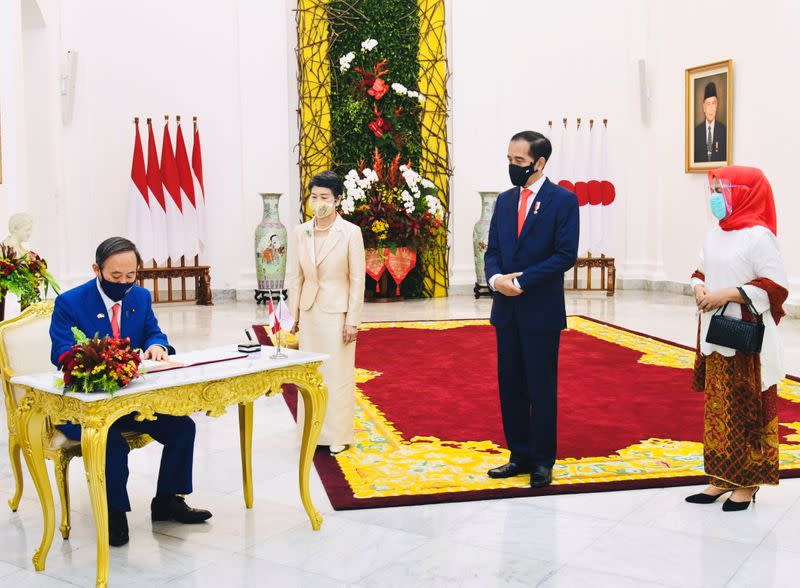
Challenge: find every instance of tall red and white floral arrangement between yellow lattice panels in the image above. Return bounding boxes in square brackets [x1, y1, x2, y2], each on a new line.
[334, 38, 446, 289]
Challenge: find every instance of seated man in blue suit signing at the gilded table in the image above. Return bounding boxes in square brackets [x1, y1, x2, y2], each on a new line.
[50, 237, 211, 546]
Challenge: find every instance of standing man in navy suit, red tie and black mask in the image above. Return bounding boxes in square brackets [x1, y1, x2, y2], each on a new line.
[484, 131, 579, 488]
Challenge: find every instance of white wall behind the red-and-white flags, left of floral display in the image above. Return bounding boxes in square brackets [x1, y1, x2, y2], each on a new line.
[0, 0, 298, 289]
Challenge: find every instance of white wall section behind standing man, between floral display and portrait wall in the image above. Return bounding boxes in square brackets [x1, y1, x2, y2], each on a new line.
[450, 0, 656, 284]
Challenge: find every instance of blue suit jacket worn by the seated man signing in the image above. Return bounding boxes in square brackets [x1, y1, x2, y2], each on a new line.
[50, 278, 174, 367]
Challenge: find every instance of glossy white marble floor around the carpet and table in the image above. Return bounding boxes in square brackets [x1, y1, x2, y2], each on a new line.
[0, 292, 800, 588]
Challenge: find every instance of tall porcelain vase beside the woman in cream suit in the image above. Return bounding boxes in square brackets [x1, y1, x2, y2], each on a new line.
[255, 192, 287, 300]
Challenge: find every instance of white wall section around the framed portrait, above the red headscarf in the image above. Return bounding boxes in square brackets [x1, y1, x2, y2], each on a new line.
[648, 0, 800, 304]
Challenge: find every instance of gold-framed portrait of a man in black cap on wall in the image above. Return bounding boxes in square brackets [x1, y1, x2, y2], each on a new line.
[686, 59, 733, 172]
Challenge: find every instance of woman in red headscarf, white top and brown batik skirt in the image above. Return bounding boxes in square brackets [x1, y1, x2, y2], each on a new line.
[686, 166, 789, 511]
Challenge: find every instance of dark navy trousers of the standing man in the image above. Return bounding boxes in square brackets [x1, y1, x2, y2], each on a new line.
[496, 321, 561, 467]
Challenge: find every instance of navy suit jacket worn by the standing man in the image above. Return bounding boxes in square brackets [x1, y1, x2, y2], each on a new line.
[484, 179, 580, 334]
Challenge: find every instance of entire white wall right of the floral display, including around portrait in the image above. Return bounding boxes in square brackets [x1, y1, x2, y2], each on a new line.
[450, 0, 800, 304]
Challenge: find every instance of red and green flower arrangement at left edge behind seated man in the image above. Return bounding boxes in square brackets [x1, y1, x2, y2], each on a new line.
[0, 244, 60, 308]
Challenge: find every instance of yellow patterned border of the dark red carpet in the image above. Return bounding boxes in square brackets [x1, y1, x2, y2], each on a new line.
[336, 317, 800, 498]
